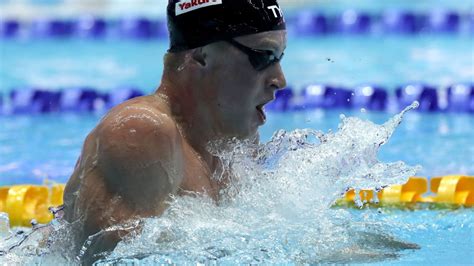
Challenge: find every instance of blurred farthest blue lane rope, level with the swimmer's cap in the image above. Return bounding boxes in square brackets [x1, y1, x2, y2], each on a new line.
[0, 10, 474, 40]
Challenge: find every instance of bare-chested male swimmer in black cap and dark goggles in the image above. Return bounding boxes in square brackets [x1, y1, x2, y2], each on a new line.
[64, 0, 286, 261]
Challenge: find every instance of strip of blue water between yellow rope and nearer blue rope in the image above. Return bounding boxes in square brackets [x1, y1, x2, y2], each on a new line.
[0, 110, 474, 185]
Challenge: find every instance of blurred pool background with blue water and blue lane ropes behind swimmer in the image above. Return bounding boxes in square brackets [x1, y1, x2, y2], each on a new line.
[0, 0, 474, 185]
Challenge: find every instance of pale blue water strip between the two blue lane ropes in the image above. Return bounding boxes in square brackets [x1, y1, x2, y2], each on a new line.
[0, 34, 474, 93]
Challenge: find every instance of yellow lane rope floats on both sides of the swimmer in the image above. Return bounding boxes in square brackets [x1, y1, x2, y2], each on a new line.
[0, 175, 474, 229]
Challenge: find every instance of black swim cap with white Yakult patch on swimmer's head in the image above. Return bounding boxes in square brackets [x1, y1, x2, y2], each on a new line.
[167, 0, 286, 52]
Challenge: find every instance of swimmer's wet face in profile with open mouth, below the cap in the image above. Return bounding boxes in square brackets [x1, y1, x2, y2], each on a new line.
[204, 30, 286, 138]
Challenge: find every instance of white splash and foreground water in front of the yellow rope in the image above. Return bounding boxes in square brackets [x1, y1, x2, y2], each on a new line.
[0, 103, 474, 264]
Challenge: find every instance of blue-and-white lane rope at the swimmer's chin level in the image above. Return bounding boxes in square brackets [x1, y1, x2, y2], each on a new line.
[0, 83, 474, 115]
